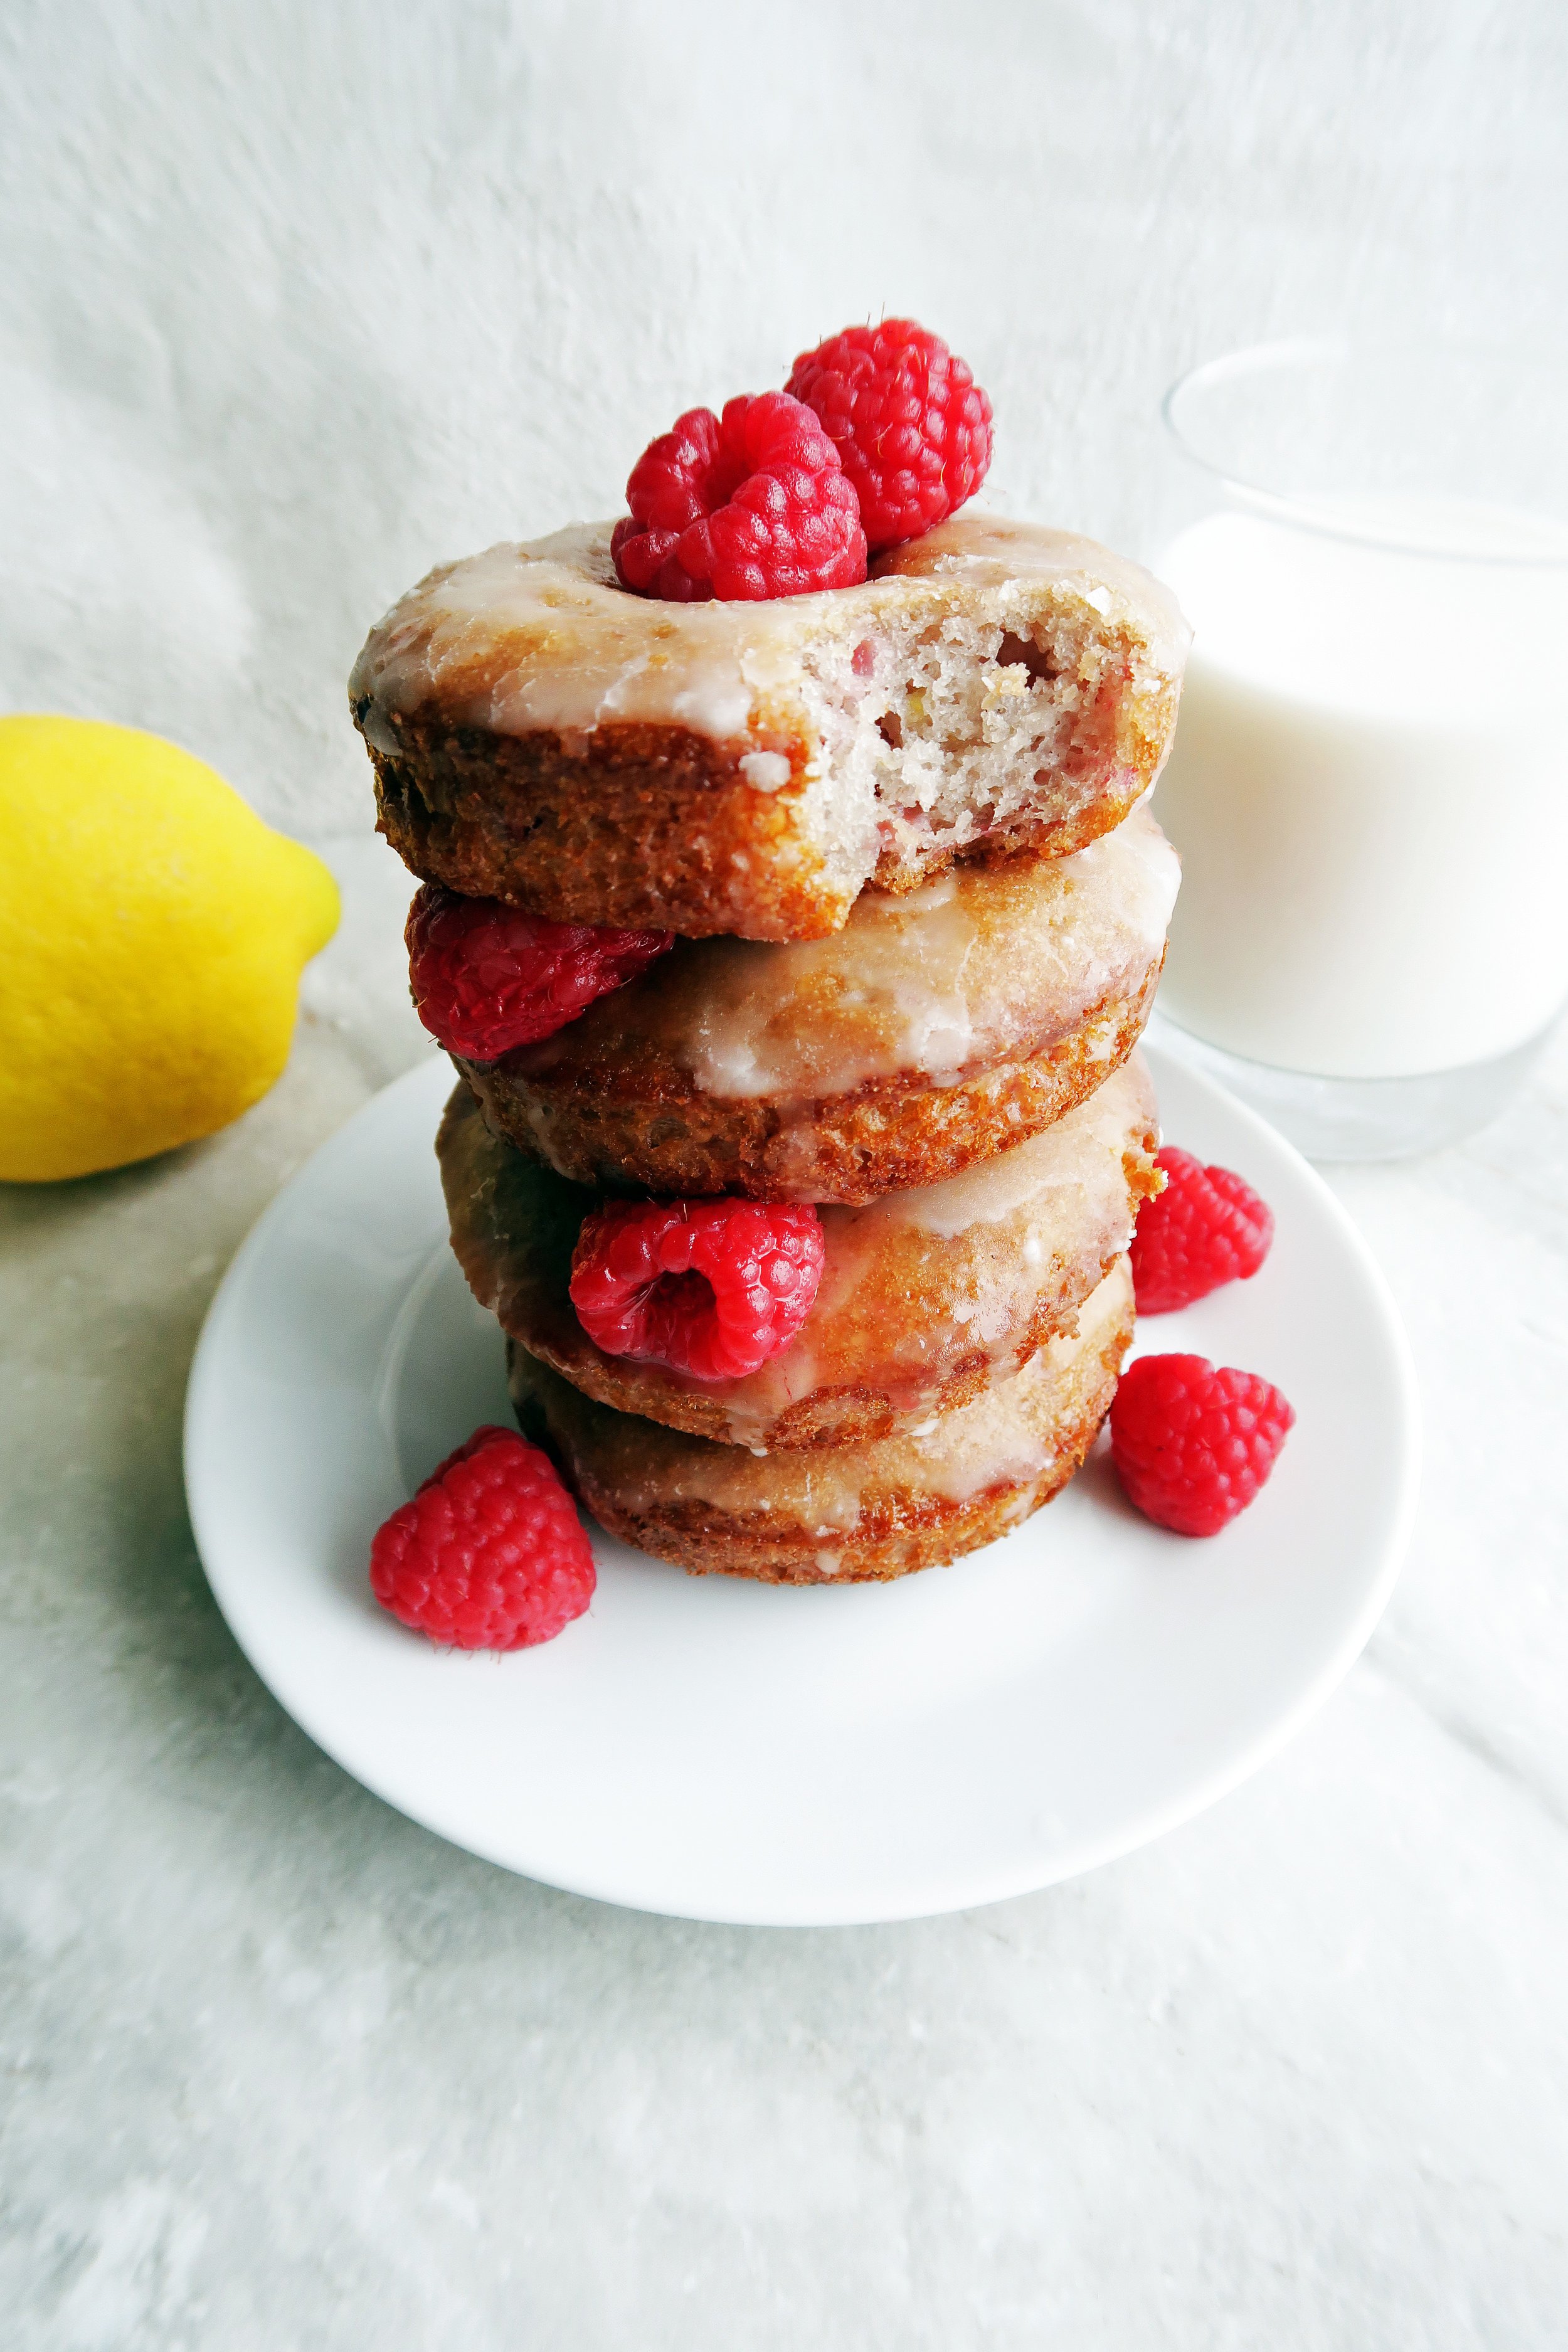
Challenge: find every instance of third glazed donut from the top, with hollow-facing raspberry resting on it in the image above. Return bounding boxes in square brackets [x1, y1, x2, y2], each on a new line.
[435, 1061, 1159, 1454]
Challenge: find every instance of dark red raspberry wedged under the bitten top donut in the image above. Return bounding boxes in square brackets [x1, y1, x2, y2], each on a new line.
[405, 882, 675, 1061]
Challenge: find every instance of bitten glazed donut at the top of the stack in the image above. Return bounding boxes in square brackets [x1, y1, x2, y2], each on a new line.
[348, 513, 1187, 938]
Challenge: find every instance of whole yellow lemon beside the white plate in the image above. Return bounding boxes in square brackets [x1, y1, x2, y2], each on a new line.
[0, 718, 339, 1181]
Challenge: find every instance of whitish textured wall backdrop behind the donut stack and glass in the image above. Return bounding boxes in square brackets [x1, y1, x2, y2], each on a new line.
[0, 0, 1568, 835]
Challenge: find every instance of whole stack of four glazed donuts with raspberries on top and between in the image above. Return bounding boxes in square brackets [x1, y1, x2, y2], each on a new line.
[350, 322, 1185, 1583]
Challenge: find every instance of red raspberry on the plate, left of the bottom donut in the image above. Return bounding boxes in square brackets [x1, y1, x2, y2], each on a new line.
[369, 1426, 595, 1649]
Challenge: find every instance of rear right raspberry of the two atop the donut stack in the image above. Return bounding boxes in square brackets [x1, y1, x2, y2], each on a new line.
[788, 317, 992, 555]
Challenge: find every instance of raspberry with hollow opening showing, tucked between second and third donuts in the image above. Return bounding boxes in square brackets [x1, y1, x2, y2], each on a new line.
[571, 1200, 823, 1380]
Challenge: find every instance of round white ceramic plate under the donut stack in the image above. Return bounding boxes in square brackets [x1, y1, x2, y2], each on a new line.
[186, 1051, 1417, 1926]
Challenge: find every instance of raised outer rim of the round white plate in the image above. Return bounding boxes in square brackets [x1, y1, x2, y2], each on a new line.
[181, 1037, 1422, 1929]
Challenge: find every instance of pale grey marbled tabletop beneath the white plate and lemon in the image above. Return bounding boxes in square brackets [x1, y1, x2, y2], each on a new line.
[0, 840, 1568, 2352]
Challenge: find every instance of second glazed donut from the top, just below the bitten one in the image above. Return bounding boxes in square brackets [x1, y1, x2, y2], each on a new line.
[458, 809, 1180, 1204]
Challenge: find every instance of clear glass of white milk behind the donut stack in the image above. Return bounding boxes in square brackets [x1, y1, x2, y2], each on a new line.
[1150, 341, 1568, 1160]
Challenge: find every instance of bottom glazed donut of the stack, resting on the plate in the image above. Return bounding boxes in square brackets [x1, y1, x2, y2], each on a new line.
[508, 1258, 1133, 1586]
